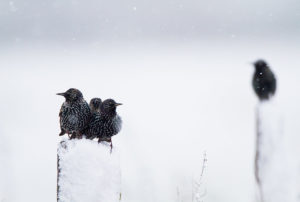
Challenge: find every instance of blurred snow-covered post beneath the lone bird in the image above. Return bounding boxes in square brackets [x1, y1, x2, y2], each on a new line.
[255, 101, 295, 202]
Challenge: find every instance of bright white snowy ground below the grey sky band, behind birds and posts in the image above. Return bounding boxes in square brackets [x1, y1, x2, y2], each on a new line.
[0, 40, 300, 202]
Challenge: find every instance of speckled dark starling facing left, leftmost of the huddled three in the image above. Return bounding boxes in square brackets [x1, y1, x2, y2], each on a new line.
[57, 88, 91, 139]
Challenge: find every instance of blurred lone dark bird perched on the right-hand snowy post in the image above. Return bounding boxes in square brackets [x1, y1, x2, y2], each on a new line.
[252, 60, 276, 101]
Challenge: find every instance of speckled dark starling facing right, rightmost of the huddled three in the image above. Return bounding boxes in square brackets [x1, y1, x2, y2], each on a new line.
[86, 99, 122, 147]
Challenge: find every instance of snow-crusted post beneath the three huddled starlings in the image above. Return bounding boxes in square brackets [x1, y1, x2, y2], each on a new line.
[57, 139, 121, 202]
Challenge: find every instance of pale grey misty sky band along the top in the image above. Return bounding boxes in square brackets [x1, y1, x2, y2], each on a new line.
[0, 0, 300, 43]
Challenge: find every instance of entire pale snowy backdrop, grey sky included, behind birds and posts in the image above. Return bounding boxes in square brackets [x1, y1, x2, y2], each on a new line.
[0, 0, 300, 202]
